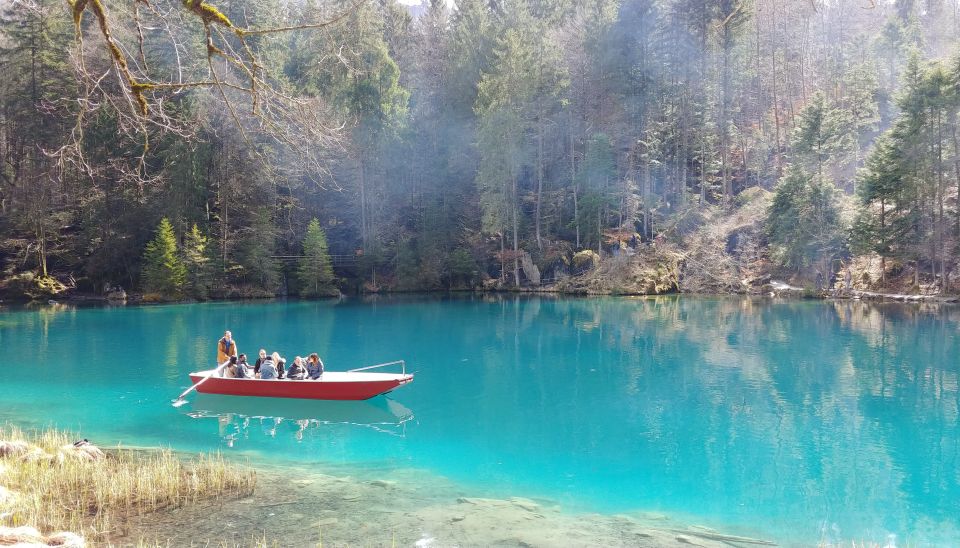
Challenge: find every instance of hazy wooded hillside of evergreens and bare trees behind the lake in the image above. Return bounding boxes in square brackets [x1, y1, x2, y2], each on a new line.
[0, 0, 960, 300]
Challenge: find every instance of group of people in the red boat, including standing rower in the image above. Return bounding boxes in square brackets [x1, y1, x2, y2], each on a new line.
[217, 331, 323, 381]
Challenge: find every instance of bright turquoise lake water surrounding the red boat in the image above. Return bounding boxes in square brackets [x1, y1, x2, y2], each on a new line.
[0, 296, 960, 544]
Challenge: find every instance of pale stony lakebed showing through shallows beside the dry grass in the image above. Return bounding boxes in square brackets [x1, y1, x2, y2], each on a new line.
[120, 470, 760, 548]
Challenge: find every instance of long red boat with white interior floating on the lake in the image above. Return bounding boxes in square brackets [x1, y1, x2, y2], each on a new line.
[187, 360, 413, 400]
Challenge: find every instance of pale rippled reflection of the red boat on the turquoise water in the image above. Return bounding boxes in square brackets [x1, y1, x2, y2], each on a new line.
[187, 394, 413, 447]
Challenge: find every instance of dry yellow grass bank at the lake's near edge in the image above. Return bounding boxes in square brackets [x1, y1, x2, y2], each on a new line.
[0, 426, 256, 542]
